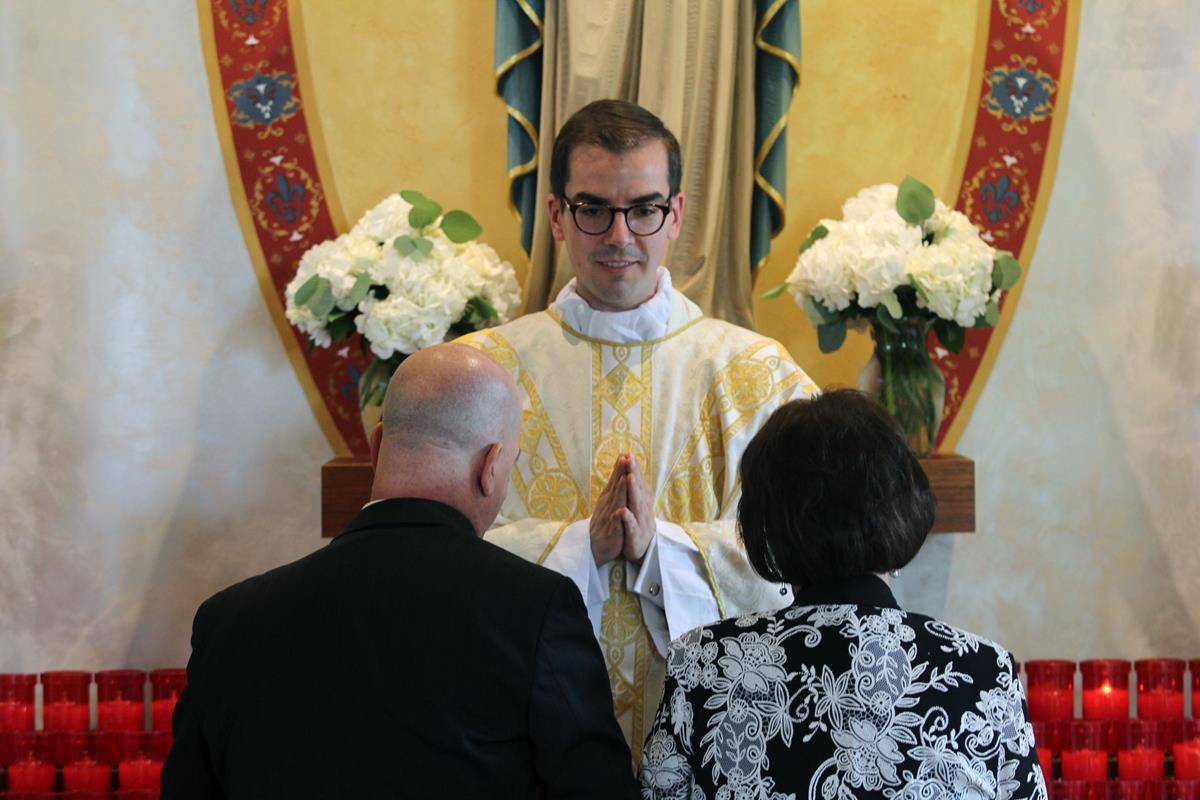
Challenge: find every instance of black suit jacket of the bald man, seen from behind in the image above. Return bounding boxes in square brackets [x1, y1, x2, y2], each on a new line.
[162, 498, 637, 800]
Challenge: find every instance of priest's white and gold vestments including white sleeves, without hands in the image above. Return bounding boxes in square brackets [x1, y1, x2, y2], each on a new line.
[458, 287, 817, 759]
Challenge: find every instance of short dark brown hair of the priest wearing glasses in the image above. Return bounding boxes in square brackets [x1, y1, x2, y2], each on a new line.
[550, 100, 683, 199]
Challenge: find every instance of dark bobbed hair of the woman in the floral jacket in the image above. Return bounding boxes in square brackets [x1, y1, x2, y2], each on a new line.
[738, 389, 937, 587]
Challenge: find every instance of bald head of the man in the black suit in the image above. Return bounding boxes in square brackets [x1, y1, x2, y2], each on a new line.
[371, 344, 521, 534]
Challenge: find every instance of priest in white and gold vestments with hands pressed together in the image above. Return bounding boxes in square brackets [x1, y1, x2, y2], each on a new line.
[461, 101, 816, 753]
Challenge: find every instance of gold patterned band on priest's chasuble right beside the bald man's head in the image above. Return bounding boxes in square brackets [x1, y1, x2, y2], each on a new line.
[456, 331, 589, 556]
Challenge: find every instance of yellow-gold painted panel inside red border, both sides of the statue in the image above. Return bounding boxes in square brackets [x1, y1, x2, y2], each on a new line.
[292, 0, 986, 386]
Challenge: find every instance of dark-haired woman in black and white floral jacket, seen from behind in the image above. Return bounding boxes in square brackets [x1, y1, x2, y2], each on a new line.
[641, 390, 1045, 800]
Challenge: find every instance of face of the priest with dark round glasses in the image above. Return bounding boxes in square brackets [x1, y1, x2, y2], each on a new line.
[548, 140, 683, 311]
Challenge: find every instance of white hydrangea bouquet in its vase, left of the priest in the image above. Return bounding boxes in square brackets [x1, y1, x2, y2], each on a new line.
[286, 191, 521, 408]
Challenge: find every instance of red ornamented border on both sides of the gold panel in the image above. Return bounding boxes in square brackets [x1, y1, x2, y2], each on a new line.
[199, 0, 1070, 453]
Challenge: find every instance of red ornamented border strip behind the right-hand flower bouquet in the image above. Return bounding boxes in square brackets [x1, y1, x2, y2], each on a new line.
[929, 0, 1070, 449]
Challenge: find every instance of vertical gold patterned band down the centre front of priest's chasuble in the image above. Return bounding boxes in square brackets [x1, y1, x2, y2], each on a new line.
[584, 339, 658, 763]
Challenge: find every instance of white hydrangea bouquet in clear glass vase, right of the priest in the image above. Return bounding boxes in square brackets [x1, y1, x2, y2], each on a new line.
[764, 176, 1021, 455]
